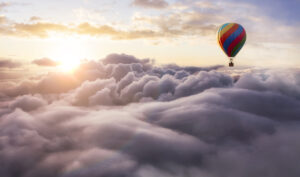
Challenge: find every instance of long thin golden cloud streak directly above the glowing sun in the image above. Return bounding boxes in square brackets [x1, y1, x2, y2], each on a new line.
[0, 22, 165, 40]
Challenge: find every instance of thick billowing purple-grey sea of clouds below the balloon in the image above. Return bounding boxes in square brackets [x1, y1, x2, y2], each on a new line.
[0, 54, 300, 177]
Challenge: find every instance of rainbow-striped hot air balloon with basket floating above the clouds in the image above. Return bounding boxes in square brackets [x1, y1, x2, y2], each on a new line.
[218, 23, 246, 67]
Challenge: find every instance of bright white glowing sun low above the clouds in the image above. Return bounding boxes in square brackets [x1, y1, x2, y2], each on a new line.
[50, 38, 86, 72]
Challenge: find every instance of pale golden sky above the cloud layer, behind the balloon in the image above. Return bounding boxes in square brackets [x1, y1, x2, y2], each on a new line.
[0, 0, 300, 67]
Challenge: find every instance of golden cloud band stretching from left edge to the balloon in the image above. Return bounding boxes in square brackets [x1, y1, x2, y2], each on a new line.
[0, 5, 220, 40]
